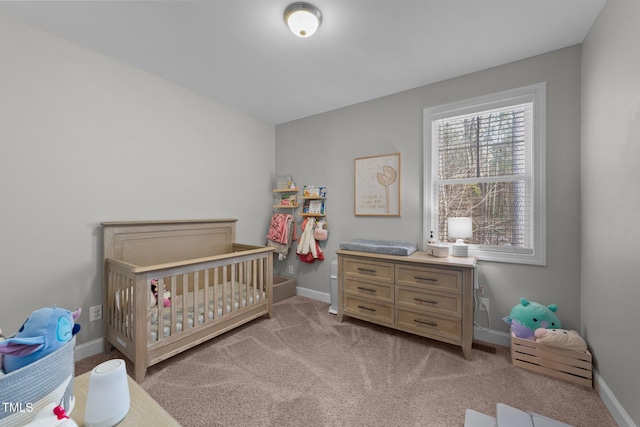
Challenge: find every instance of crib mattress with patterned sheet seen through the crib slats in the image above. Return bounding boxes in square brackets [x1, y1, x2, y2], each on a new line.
[151, 284, 267, 342]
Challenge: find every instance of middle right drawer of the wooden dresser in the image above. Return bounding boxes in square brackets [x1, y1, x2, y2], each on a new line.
[395, 286, 462, 317]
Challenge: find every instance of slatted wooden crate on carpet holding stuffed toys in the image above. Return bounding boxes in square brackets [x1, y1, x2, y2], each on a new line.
[511, 333, 593, 387]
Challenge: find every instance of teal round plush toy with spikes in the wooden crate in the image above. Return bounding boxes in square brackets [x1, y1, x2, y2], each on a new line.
[502, 298, 562, 341]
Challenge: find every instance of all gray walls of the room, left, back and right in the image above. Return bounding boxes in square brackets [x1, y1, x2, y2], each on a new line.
[0, 0, 640, 425]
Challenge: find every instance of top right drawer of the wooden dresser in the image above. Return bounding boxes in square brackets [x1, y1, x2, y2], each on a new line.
[396, 265, 462, 293]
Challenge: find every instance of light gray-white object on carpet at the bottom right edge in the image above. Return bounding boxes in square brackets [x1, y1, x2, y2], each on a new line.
[464, 403, 573, 427]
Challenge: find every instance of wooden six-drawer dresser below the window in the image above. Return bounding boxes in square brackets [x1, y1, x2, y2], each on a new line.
[336, 250, 476, 360]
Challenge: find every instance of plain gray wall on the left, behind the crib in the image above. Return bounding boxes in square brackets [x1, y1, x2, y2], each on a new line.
[0, 13, 275, 344]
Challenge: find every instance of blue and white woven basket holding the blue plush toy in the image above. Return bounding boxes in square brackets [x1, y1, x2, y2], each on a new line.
[0, 337, 76, 427]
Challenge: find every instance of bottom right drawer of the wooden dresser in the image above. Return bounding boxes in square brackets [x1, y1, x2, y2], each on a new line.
[396, 308, 462, 342]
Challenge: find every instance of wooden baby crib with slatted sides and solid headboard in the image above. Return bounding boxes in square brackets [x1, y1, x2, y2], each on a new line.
[101, 219, 274, 383]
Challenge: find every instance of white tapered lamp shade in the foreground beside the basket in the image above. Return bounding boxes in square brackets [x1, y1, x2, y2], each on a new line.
[84, 359, 131, 427]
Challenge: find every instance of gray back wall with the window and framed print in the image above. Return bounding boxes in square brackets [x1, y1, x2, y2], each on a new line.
[276, 46, 581, 333]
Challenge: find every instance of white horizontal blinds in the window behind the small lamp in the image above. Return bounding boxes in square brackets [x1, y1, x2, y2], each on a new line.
[431, 102, 533, 253]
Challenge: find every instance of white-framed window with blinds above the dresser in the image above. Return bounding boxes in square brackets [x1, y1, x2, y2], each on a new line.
[423, 83, 546, 265]
